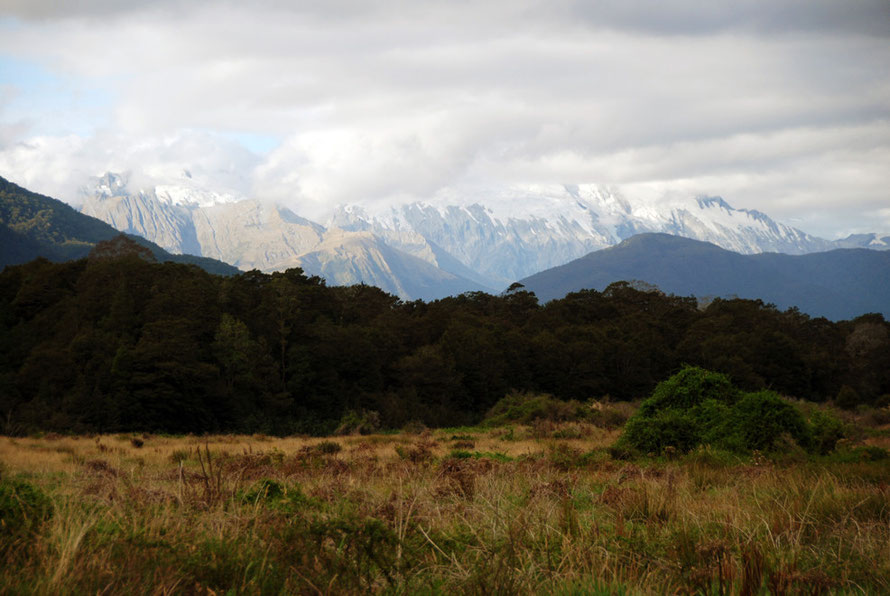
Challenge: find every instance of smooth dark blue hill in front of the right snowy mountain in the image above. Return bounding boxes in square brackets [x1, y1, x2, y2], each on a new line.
[520, 234, 890, 320]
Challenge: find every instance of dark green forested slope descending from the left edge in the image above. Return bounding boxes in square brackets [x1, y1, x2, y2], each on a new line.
[0, 173, 238, 275]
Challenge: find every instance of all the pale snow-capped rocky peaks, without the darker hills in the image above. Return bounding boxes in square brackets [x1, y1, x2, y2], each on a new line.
[83, 174, 835, 298]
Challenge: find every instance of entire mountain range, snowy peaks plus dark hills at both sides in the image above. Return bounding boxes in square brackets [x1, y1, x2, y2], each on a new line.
[0, 174, 890, 319]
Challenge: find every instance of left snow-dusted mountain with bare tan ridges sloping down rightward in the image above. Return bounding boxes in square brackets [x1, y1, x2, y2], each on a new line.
[81, 174, 491, 299]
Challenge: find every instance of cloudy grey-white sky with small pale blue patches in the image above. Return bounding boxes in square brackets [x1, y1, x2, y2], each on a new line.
[0, 0, 890, 239]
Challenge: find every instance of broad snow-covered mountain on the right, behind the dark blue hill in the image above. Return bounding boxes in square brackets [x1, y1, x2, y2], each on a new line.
[327, 185, 833, 287]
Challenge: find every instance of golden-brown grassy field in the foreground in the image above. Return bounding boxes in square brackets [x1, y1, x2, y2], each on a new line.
[0, 423, 890, 594]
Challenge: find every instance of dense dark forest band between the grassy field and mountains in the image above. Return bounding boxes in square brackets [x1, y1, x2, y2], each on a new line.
[0, 249, 890, 433]
